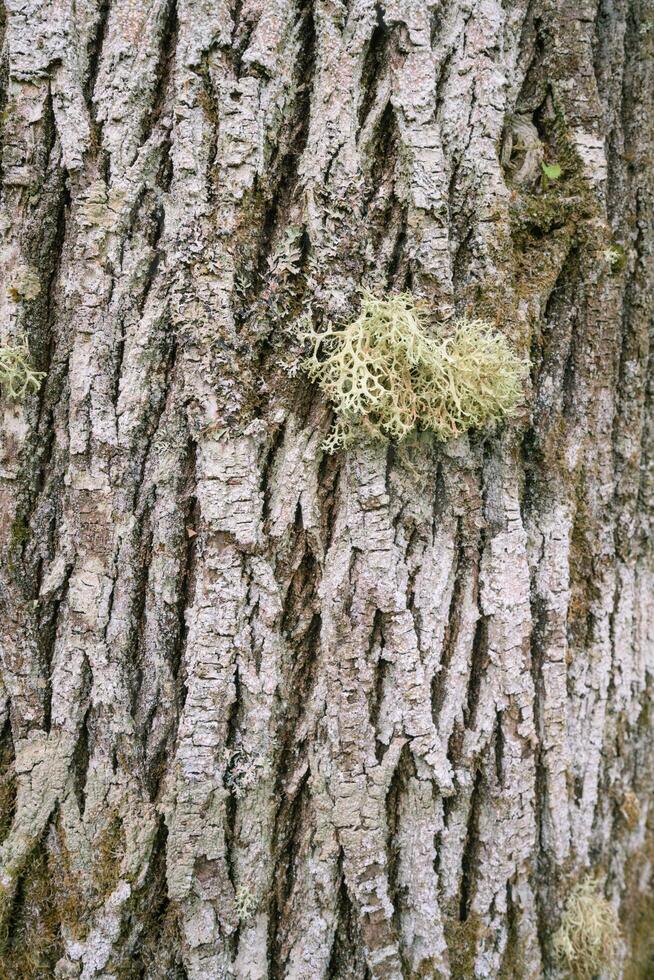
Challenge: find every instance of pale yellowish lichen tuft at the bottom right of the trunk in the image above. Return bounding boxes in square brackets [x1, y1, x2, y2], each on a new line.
[553, 878, 620, 980]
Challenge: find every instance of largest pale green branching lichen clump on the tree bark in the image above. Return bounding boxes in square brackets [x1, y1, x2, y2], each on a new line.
[301, 293, 528, 452]
